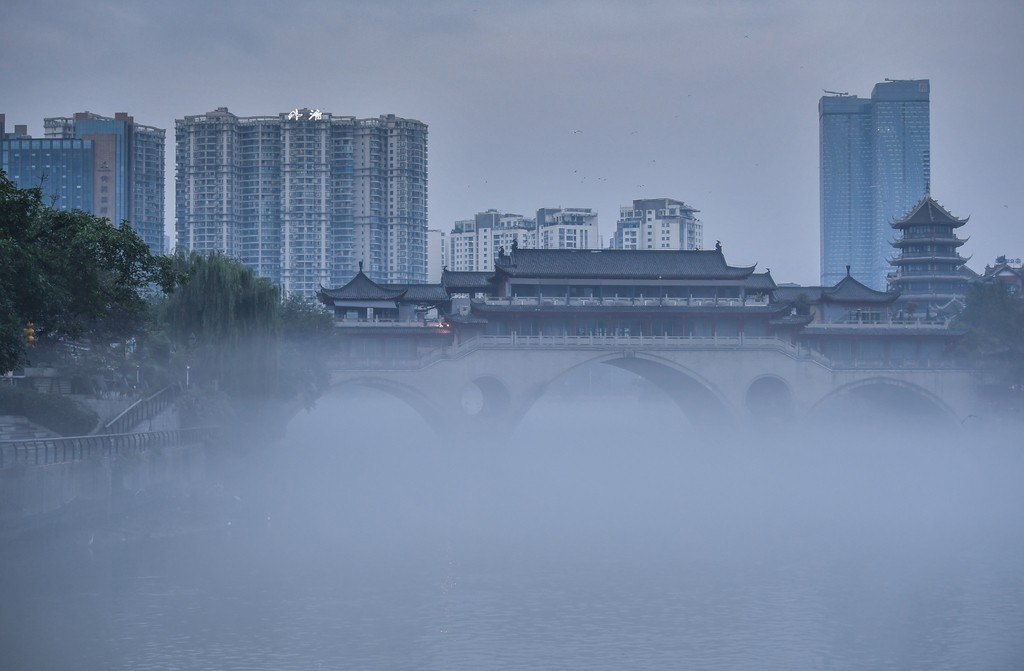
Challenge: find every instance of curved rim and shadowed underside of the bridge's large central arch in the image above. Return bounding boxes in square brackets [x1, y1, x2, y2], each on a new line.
[512, 351, 735, 425]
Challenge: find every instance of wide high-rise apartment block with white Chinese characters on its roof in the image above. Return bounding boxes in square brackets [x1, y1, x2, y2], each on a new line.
[175, 108, 428, 296]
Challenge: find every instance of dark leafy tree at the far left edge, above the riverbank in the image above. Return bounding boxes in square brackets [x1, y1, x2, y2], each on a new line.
[0, 171, 180, 371]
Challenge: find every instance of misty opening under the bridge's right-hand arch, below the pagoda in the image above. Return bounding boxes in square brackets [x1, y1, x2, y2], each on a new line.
[810, 377, 956, 426]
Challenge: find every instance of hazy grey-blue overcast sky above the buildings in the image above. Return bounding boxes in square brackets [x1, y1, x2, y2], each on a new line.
[0, 0, 1024, 285]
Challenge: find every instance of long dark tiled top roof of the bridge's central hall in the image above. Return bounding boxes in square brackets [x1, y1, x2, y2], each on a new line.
[495, 249, 755, 280]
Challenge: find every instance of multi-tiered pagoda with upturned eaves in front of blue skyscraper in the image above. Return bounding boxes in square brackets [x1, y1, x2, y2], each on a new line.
[889, 193, 974, 314]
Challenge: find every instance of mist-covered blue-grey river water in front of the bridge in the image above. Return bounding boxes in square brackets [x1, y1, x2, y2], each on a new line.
[0, 395, 1024, 671]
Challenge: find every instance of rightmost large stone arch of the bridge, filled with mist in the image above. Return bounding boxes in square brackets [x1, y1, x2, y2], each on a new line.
[810, 375, 956, 421]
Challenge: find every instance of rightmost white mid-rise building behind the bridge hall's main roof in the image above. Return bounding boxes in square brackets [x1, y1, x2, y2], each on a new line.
[611, 198, 703, 249]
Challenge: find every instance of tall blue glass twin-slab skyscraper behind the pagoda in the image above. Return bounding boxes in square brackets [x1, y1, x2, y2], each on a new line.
[818, 79, 931, 291]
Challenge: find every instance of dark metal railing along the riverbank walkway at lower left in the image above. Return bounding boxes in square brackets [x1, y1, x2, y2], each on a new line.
[0, 427, 218, 469]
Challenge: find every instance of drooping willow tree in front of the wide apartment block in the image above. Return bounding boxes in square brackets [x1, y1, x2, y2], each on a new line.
[157, 252, 281, 396]
